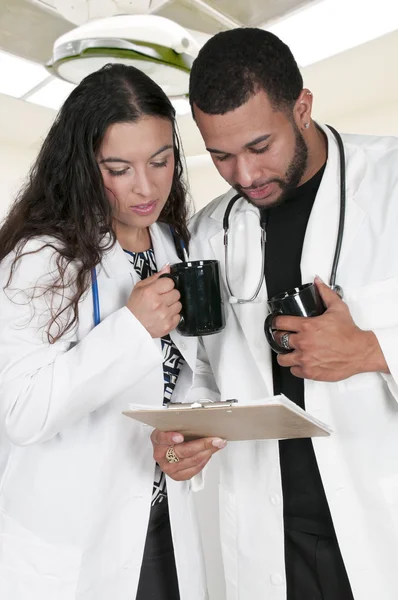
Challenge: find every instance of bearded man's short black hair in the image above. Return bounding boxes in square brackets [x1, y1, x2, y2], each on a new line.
[189, 27, 303, 115]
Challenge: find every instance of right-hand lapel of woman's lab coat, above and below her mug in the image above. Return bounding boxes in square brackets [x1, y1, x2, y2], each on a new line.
[150, 223, 197, 372]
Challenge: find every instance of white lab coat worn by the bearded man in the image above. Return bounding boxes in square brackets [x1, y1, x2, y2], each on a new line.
[188, 125, 398, 600]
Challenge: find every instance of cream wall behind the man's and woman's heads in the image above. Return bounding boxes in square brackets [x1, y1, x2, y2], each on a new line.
[0, 26, 398, 156]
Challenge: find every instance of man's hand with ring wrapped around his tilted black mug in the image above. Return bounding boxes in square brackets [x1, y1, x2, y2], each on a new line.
[274, 277, 389, 381]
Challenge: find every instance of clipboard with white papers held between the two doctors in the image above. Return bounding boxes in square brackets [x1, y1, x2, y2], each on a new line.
[123, 394, 331, 441]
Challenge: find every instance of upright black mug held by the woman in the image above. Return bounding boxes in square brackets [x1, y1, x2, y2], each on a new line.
[160, 260, 225, 336]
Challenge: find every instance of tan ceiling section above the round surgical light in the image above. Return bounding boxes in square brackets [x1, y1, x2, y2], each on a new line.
[0, 0, 316, 64]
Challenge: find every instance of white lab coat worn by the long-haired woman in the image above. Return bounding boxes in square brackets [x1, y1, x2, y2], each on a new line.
[0, 224, 211, 600]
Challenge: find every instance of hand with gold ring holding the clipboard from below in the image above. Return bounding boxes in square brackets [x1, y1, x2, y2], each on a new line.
[151, 429, 227, 481]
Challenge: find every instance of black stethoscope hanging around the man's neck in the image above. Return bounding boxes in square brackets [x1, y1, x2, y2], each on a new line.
[223, 125, 346, 304]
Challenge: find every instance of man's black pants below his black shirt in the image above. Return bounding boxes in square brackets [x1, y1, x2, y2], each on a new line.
[285, 528, 354, 600]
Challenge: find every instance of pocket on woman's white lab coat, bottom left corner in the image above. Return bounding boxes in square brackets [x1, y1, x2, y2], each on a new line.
[0, 511, 81, 600]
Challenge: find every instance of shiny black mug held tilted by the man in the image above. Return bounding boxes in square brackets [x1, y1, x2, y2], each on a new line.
[264, 283, 326, 354]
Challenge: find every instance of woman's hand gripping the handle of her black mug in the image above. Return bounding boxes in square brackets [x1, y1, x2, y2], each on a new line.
[127, 265, 182, 338]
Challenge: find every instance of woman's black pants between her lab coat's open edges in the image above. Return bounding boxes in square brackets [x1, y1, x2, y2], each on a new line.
[136, 499, 180, 600]
